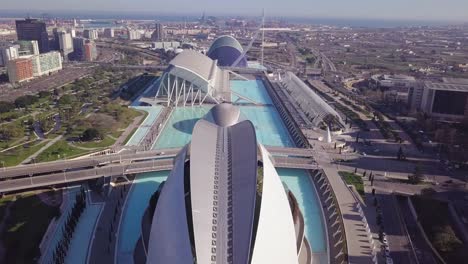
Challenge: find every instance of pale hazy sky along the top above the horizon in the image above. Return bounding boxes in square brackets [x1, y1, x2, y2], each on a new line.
[0, 0, 468, 21]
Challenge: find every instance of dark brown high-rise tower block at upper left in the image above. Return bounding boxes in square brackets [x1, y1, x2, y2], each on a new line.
[16, 18, 50, 53]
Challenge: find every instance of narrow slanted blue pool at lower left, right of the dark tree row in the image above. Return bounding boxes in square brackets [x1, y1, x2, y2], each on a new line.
[65, 204, 102, 264]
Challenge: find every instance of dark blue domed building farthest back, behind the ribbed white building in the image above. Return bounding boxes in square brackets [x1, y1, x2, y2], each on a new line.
[206, 36, 247, 67]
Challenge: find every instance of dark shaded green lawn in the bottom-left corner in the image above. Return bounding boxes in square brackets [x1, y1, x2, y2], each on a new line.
[2, 193, 60, 263]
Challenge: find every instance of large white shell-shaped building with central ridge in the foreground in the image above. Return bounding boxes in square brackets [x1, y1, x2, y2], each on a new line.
[134, 104, 312, 264]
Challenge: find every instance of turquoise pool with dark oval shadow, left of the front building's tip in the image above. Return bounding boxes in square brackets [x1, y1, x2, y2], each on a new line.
[153, 106, 213, 149]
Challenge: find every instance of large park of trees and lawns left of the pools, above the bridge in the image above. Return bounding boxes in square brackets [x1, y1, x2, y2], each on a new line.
[0, 68, 155, 166]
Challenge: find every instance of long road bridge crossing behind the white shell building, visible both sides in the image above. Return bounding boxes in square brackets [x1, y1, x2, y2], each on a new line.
[0, 147, 318, 192]
